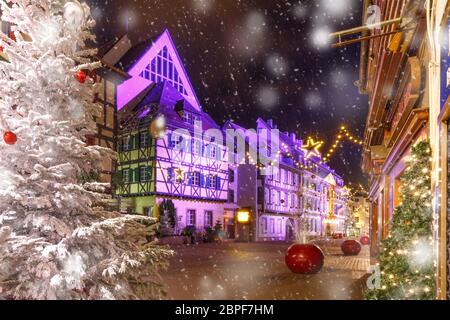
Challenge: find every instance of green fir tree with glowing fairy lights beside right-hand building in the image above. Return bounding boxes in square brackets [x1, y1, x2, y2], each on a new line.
[366, 141, 436, 300]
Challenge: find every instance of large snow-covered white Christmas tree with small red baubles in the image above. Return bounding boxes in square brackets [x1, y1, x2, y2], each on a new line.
[0, 0, 171, 299]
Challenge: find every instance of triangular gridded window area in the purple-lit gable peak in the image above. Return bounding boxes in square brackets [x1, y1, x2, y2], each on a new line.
[139, 47, 187, 95]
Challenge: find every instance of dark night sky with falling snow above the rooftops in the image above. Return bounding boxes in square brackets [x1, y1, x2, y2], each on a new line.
[87, 0, 368, 188]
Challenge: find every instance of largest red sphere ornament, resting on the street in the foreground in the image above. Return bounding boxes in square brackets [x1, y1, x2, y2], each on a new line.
[284, 244, 325, 274]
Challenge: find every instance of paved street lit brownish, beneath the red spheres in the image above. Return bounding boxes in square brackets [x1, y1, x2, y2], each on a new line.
[162, 241, 369, 300]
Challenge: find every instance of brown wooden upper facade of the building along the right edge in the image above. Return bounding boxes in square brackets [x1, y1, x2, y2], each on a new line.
[359, 0, 430, 257]
